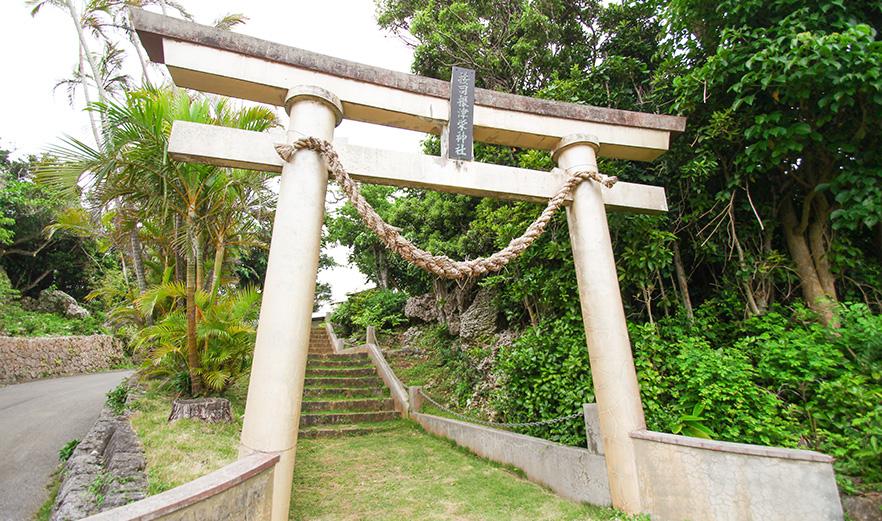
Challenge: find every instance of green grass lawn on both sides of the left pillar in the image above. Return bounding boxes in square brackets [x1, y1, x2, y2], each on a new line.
[132, 391, 627, 520]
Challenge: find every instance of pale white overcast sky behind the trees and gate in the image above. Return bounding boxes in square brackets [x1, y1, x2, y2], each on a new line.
[0, 0, 424, 308]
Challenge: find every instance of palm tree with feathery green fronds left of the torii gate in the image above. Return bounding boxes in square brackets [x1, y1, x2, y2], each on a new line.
[38, 88, 276, 394]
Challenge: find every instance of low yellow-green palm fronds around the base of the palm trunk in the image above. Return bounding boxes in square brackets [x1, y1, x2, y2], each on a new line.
[134, 283, 260, 394]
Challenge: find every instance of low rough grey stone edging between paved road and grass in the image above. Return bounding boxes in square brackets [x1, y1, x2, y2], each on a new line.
[51, 407, 147, 521]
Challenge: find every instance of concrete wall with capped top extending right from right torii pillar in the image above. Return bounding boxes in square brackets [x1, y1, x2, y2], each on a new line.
[631, 431, 843, 521]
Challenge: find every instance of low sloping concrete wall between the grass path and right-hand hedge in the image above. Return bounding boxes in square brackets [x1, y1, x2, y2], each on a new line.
[411, 412, 604, 504]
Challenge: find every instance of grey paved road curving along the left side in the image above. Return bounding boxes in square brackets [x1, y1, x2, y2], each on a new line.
[0, 371, 131, 521]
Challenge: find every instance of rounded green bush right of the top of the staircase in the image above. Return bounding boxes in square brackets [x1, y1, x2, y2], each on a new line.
[329, 289, 407, 335]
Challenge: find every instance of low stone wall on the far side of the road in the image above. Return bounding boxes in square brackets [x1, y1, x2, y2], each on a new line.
[0, 335, 123, 384]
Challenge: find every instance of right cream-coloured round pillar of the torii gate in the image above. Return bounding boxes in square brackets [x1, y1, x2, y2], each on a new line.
[552, 134, 646, 514]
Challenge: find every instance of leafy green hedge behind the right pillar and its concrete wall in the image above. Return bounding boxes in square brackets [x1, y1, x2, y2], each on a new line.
[496, 301, 882, 492]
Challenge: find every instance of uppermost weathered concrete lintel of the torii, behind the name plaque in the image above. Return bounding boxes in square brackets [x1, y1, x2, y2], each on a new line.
[131, 9, 686, 161]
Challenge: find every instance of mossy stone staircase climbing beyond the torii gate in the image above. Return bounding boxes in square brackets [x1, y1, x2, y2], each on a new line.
[300, 328, 399, 438]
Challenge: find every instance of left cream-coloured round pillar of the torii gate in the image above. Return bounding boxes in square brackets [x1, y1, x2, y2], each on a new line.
[239, 86, 343, 521]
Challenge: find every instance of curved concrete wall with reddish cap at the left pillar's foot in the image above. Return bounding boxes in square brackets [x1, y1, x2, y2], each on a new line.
[86, 454, 279, 521]
